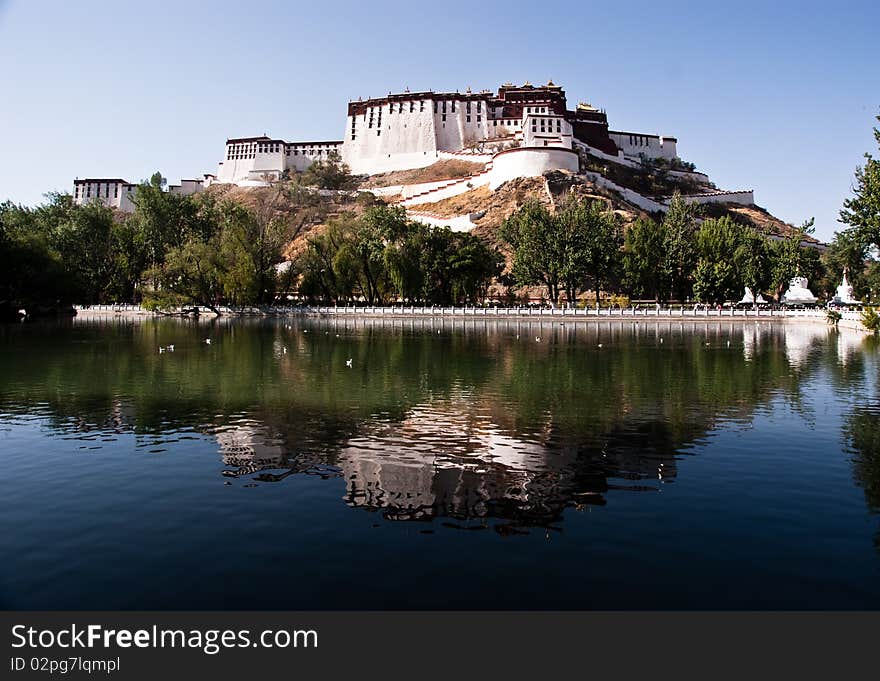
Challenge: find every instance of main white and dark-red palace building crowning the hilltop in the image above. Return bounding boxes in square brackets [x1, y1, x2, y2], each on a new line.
[217, 81, 677, 186]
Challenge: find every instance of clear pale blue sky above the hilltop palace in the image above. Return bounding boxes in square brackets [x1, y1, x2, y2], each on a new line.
[0, 0, 880, 239]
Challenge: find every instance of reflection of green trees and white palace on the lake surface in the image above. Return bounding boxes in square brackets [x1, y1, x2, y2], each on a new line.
[0, 320, 868, 531]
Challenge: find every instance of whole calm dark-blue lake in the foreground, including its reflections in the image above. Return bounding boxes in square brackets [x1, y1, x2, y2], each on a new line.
[0, 320, 880, 609]
